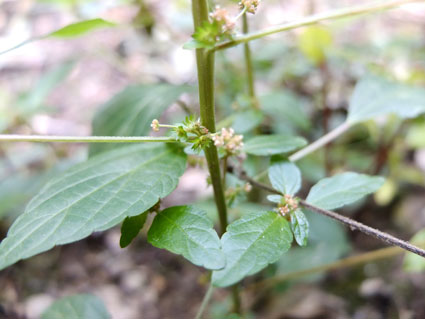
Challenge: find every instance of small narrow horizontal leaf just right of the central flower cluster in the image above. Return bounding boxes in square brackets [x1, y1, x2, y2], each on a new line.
[244, 135, 307, 156]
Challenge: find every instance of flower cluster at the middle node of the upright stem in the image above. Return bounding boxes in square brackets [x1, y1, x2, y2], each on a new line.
[151, 116, 243, 156]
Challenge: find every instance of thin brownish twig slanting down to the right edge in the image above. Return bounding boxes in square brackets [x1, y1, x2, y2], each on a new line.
[229, 166, 425, 257]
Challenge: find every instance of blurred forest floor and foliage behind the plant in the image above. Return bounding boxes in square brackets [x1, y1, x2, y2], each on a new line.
[0, 0, 425, 319]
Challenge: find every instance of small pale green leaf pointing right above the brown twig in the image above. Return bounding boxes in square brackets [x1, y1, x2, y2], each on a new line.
[306, 172, 385, 209]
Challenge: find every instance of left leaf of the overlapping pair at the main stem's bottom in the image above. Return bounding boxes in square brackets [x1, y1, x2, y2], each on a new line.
[148, 206, 225, 269]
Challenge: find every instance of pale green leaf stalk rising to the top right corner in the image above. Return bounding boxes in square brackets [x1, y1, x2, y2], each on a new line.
[213, 0, 424, 51]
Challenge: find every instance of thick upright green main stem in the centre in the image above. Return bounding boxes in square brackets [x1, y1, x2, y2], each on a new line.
[192, 0, 227, 234]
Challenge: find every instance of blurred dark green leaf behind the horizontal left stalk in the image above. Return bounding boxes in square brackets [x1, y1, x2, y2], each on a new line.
[90, 84, 190, 156]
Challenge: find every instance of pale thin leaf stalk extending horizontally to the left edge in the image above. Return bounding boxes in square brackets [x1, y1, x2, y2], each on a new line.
[0, 134, 178, 143]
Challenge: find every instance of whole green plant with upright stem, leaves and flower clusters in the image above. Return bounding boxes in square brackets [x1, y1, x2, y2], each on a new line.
[0, 0, 425, 318]
